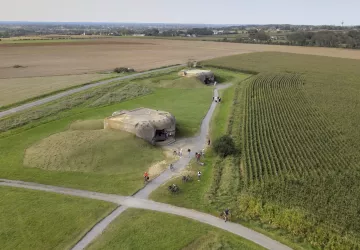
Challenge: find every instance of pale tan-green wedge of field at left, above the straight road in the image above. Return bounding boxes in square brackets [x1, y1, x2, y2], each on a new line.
[0, 74, 115, 107]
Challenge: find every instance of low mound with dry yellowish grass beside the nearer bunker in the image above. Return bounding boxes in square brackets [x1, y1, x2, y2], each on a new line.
[24, 127, 164, 174]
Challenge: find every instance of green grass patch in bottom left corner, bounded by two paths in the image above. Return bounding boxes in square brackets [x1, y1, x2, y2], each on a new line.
[0, 187, 115, 250]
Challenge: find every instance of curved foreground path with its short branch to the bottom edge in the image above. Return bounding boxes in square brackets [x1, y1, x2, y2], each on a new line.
[0, 179, 291, 250]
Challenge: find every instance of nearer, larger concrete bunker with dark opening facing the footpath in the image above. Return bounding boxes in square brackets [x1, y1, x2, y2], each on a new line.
[104, 108, 176, 145]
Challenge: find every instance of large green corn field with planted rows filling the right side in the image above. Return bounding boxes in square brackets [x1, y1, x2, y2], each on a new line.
[204, 52, 360, 250]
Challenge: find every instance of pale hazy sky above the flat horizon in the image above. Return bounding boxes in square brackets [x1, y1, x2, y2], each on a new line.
[0, 0, 360, 25]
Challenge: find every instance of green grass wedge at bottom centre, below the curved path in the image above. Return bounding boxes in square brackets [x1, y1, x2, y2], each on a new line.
[87, 209, 263, 250]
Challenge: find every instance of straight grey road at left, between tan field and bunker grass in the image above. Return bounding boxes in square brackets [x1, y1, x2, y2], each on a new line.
[0, 65, 183, 118]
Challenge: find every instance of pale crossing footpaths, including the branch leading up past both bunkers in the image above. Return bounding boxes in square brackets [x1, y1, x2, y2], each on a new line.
[0, 84, 291, 250]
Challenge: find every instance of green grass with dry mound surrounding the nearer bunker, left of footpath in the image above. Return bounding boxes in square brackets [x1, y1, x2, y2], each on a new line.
[0, 70, 246, 195]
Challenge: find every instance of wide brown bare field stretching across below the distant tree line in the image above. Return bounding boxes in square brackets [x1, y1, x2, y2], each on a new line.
[0, 38, 360, 78]
